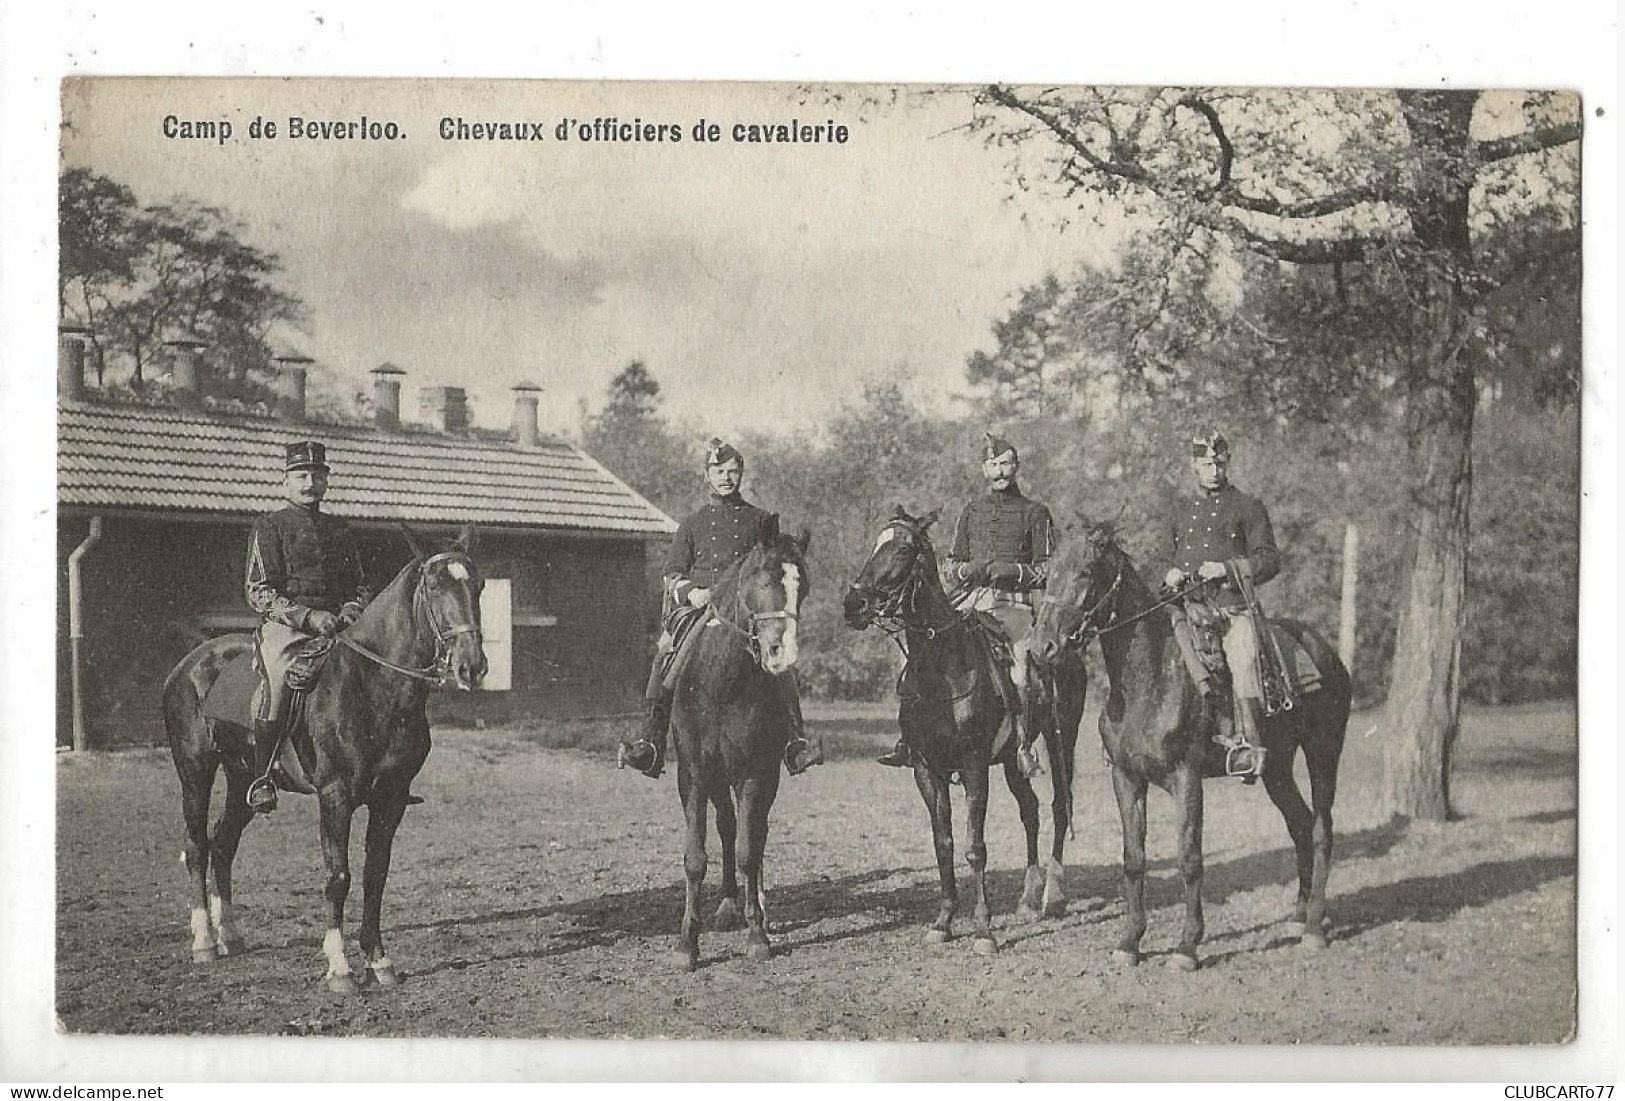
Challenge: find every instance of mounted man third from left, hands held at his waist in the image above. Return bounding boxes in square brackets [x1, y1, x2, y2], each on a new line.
[881, 432, 1055, 776]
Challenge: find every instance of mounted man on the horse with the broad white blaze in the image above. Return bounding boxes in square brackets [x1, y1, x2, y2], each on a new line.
[619, 437, 824, 778]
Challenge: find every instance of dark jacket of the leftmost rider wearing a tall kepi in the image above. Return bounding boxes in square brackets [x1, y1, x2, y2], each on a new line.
[244, 505, 372, 630]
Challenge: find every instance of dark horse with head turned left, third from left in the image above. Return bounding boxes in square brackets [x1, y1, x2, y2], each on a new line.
[842, 505, 1086, 955]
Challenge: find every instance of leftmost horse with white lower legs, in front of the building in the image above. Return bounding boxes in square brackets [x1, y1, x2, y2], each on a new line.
[163, 525, 486, 994]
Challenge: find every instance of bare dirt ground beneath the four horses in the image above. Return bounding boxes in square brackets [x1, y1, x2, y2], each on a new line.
[57, 705, 1576, 1044]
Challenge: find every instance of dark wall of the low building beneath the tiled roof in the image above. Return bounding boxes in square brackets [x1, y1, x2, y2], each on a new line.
[57, 516, 650, 747]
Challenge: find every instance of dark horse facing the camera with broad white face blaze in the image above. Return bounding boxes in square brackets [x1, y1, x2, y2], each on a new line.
[671, 515, 811, 971]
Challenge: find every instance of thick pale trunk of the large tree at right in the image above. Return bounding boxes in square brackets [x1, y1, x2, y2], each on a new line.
[1383, 91, 1477, 820]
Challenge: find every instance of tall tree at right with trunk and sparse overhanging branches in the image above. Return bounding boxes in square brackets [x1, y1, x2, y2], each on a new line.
[982, 86, 1580, 818]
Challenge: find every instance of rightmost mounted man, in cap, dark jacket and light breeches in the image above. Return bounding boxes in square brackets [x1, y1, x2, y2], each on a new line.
[1164, 429, 1281, 779]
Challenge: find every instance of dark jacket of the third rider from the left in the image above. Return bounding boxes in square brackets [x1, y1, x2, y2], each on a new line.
[946, 482, 1055, 604]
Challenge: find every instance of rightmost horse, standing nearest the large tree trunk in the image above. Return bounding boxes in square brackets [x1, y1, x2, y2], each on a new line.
[1032, 523, 1350, 971]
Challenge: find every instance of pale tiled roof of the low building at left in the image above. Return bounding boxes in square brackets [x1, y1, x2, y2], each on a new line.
[57, 401, 676, 536]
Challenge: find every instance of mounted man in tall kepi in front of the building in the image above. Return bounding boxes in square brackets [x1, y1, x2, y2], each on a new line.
[244, 440, 373, 814]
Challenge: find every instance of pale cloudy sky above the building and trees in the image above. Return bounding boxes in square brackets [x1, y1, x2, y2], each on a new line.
[63, 80, 1116, 434]
